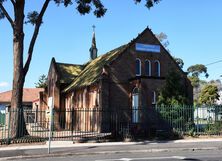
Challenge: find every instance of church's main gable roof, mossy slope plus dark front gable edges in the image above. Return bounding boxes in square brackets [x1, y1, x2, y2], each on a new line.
[63, 27, 186, 92]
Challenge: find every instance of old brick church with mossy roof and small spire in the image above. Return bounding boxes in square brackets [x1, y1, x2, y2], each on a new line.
[39, 28, 193, 135]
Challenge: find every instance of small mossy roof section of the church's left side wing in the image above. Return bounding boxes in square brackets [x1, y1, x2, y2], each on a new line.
[56, 63, 84, 83]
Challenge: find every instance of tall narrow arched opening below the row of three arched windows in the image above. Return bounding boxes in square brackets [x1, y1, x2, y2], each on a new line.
[132, 87, 139, 123]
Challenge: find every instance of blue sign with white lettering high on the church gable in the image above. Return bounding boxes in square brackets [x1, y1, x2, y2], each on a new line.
[136, 43, 160, 53]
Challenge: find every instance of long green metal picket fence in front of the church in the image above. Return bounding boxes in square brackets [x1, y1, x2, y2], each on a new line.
[0, 106, 222, 144]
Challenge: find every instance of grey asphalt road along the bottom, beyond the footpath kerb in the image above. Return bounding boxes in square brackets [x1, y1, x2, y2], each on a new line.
[10, 150, 222, 161]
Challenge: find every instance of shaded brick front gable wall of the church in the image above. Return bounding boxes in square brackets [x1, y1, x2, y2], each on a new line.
[106, 28, 193, 108]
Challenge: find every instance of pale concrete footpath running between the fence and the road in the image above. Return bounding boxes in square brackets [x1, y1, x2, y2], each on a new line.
[0, 138, 222, 160]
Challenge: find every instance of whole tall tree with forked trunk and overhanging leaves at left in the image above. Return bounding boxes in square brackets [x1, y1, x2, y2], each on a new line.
[0, 0, 160, 137]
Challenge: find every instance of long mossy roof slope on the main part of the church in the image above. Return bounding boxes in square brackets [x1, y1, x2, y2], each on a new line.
[63, 45, 128, 92]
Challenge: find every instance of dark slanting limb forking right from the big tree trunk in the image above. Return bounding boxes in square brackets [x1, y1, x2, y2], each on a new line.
[24, 0, 50, 76]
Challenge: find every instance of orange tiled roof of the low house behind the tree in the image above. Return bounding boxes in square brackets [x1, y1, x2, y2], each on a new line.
[0, 88, 44, 103]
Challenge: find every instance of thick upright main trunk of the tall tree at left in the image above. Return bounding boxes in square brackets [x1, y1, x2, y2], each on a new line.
[10, 0, 27, 138]
